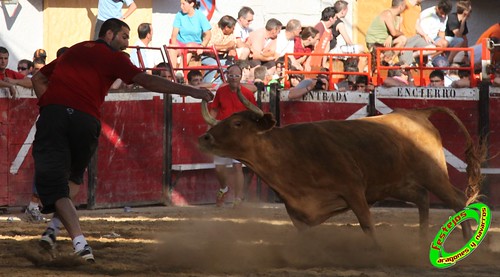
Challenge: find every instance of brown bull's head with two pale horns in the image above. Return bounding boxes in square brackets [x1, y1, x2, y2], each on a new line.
[198, 87, 276, 159]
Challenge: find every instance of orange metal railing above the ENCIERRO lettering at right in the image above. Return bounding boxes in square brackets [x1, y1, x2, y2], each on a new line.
[375, 47, 476, 87]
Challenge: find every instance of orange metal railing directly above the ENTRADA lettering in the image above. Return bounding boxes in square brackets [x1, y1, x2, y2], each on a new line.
[284, 53, 372, 89]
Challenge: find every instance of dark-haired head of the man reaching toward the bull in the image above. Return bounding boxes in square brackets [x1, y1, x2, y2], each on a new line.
[99, 18, 130, 50]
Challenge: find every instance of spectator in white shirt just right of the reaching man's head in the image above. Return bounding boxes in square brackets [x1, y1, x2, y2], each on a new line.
[130, 23, 155, 74]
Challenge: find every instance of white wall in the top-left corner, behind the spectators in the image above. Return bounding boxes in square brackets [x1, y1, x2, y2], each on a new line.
[0, 0, 43, 70]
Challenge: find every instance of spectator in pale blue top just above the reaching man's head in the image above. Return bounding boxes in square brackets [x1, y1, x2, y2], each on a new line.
[94, 0, 137, 40]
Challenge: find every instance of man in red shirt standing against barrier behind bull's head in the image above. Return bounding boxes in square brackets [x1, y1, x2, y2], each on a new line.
[210, 65, 257, 207]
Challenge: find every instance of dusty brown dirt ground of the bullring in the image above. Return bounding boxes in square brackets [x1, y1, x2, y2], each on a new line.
[0, 203, 500, 277]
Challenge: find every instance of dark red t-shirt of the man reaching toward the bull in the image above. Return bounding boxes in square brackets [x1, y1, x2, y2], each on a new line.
[38, 40, 142, 119]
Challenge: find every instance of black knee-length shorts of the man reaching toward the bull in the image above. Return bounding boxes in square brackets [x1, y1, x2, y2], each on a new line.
[33, 105, 101, 213]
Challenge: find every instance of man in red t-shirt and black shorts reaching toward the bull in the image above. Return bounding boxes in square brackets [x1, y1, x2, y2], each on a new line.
[31, 18, 213, 262]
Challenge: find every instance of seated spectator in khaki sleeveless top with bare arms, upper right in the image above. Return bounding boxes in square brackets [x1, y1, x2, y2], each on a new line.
[366, 0, 406, 52]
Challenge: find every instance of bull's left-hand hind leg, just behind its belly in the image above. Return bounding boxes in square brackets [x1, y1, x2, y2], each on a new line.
[391, 185, 429, 241]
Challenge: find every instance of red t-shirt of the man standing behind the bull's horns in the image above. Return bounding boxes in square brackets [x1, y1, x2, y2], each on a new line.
[210, 85, 257, 120]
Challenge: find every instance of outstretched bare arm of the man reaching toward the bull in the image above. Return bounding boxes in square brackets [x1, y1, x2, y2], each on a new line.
[132, 72, 214, 101]
